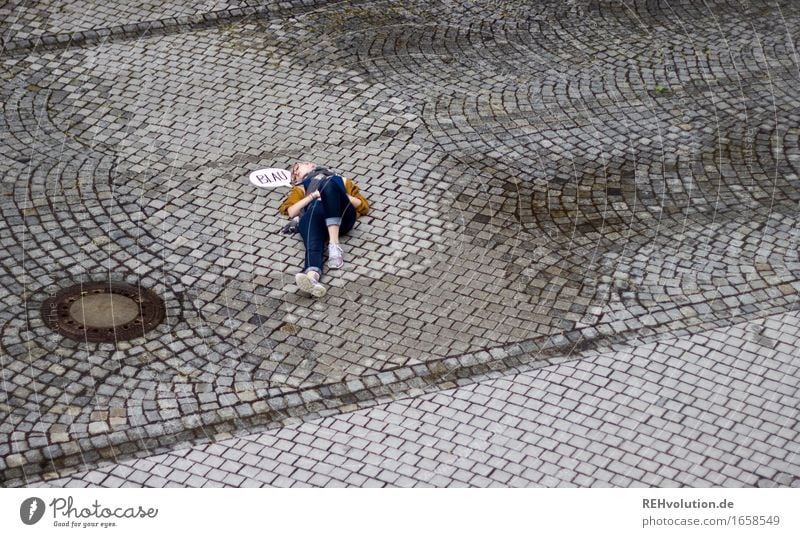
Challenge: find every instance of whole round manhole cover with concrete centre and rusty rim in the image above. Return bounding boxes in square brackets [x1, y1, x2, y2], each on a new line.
[42, 282, 165, 343]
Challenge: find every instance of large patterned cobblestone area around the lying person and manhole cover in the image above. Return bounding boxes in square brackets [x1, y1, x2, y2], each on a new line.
[0, 0, 800, 485]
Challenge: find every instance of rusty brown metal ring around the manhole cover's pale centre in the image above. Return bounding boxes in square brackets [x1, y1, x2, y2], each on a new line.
[41, 281, 166, 343]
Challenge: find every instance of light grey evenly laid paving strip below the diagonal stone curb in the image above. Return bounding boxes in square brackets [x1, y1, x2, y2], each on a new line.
[32, 312, 800, 487]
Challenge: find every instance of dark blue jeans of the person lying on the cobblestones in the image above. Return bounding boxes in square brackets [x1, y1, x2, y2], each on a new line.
[300, 175, 356, 277]
